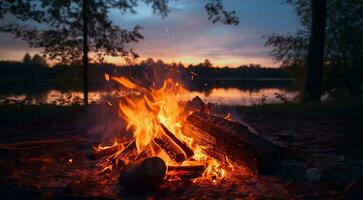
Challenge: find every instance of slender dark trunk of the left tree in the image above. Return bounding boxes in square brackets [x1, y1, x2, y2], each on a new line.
[82, 0, 88, 106]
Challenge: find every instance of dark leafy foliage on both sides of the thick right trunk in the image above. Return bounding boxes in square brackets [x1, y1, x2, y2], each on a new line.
[266, 0, 363, 96]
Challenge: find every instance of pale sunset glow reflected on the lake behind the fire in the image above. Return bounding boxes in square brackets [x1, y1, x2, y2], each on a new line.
[0, 88, 298, 106]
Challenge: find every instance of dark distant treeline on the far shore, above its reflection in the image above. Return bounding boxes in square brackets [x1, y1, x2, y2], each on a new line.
[0, 54, 290, 81]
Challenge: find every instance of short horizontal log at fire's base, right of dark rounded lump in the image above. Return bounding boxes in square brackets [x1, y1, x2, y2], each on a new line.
[167, 165, 206, 179]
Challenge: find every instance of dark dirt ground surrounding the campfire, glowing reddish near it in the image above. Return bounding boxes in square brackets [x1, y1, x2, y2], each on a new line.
[0, 104, 363, 199]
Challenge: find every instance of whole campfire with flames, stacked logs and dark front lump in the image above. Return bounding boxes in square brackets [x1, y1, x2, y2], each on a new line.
[93, 75, 279, 192]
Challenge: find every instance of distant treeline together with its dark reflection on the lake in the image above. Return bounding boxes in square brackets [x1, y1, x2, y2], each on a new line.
[0, 55, 290, 90]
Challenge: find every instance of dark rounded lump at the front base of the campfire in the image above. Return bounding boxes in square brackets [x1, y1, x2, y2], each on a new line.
[119, 157, 166, 193]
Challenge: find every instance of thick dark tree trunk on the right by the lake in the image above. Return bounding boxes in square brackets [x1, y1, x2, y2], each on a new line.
[304, 0, 327, 102]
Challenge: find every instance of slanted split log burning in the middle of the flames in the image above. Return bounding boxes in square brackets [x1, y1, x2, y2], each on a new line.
[154, 124, 194, 163]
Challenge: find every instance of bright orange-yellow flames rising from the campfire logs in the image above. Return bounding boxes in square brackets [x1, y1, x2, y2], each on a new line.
[98, 74, 230, 182]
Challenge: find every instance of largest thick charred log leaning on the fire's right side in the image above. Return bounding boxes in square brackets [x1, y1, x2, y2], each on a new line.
[183, 112, 280, 174]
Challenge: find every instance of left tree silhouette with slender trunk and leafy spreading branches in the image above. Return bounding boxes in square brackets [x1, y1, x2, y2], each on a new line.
[0, 0, 238, 105]
